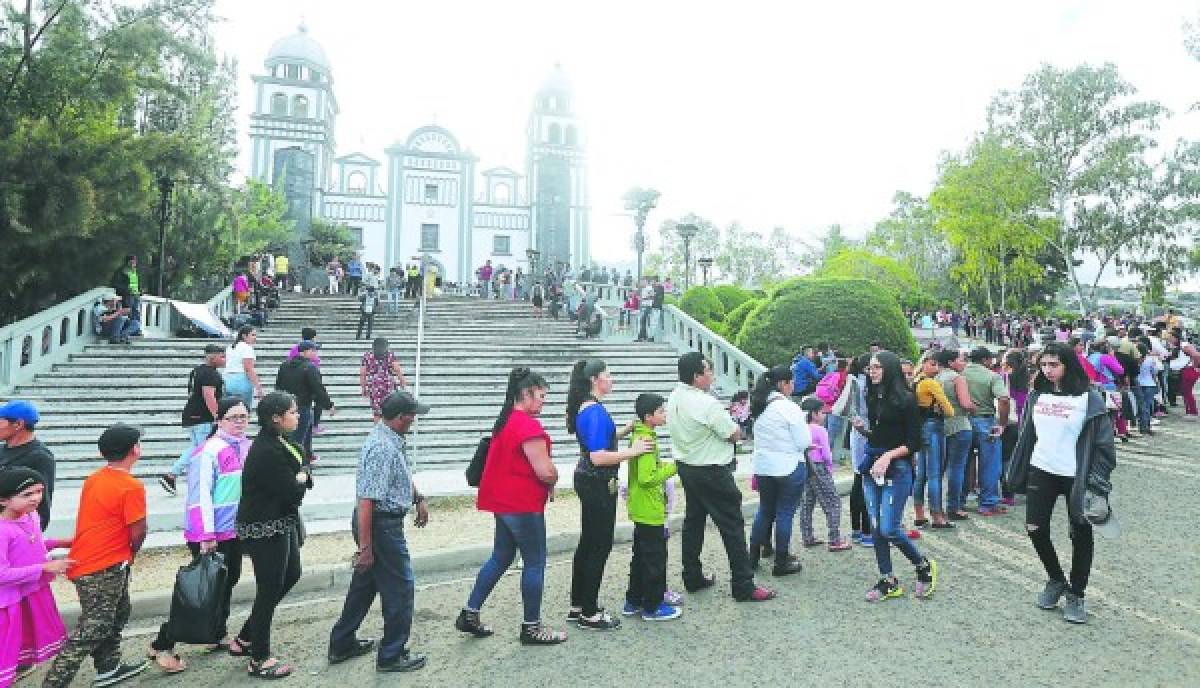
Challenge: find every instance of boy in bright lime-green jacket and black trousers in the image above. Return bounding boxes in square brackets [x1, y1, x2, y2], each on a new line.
[622, 394, 683, 621]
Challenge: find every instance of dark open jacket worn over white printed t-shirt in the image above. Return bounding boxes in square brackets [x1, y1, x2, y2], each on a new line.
[1008, 388, 1117, 525]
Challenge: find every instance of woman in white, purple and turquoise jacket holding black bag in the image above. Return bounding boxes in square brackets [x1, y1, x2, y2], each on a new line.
[150, 396, 250, 672]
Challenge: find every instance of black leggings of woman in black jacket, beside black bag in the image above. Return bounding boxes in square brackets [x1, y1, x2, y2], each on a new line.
[238, 530, 300, 662]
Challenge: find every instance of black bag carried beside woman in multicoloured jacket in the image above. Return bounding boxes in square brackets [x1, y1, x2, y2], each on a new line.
[167, 552, 229, 645]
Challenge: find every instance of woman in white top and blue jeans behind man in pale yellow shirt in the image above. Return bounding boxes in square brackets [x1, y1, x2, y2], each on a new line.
[750, 365, 812, 576]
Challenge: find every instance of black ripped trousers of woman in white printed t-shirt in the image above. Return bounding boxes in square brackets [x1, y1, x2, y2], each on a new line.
[1025, 466, 1094, 597]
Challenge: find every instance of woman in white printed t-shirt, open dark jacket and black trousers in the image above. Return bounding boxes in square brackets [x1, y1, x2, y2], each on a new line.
[1008, 342, 1120, 623]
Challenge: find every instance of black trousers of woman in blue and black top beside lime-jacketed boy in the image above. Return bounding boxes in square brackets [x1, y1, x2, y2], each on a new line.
[571, 473, 617, 616]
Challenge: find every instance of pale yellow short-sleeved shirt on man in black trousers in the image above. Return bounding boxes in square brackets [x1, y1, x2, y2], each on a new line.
[667, 382, 738, 466]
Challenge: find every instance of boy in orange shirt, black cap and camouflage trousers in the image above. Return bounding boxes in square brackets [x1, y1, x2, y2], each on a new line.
[43, 423, 146, 688]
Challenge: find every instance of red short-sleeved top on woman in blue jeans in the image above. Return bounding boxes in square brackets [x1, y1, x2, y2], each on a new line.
[475, 409, 551, 514]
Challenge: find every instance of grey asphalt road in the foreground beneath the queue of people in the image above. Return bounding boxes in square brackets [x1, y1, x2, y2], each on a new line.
[32, 413, 1200, 688]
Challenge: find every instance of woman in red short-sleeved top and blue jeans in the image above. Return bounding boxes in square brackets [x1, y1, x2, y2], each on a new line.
[455, 367, 566, 645]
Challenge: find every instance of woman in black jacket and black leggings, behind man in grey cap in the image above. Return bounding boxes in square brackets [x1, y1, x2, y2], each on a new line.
[229, 391, 312, 678]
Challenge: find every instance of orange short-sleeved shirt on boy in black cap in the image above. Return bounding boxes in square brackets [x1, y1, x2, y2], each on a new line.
[67, 466, 146, 580]
